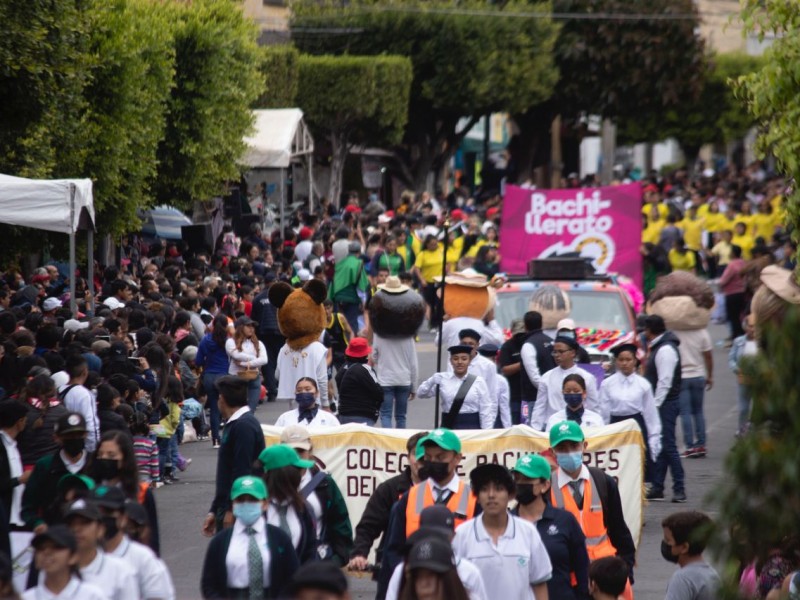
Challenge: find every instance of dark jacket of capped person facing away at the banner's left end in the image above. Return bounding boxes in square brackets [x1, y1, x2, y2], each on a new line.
[210, 412, 264, 516]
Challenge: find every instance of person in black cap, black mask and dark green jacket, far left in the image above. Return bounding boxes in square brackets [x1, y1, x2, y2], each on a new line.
[21, 412, 91, 533]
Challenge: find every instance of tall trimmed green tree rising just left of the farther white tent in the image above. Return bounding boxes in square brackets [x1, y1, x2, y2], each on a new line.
[155, 0, 263, 207]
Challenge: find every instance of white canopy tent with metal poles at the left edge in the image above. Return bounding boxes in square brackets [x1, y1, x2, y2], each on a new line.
[0, 174, 94, 314]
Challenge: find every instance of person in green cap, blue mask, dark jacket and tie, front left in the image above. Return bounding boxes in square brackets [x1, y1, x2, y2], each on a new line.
[200, 475, 299, 600]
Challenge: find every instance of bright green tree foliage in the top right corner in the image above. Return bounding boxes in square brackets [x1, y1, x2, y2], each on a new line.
[735, 0, 800, 231]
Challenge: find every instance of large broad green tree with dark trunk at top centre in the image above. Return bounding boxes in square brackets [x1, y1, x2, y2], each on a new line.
[291, 0, 557, 190]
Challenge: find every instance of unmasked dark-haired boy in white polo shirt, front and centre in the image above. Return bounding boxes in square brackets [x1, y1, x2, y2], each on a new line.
[453, 464, 552, 600]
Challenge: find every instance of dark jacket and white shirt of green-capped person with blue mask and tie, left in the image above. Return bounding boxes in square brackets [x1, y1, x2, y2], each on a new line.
[200, 517, 299, 598]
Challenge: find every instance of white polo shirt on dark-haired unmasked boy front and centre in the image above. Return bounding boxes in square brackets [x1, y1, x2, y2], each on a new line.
[453, 515, 553, 600]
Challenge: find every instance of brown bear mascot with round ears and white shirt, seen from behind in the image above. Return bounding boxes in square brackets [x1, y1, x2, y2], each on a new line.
[269, 279, 330, 408]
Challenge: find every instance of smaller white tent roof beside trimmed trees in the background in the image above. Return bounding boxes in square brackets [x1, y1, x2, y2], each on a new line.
[242, 108, 314, 169]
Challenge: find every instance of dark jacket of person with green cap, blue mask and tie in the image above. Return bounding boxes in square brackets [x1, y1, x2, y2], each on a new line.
[200, 525, 300, 599]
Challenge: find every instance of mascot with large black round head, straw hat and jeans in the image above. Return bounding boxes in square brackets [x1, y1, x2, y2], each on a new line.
[368, 275, 425, 429]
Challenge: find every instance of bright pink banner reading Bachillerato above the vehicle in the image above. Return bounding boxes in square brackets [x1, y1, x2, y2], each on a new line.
[500, 183, 642, 286]
